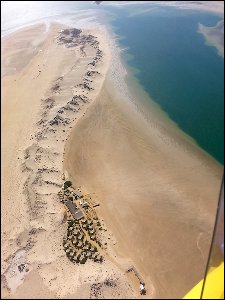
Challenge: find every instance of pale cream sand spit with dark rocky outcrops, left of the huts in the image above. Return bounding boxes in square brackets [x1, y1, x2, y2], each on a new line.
[1, 24, 134, 299]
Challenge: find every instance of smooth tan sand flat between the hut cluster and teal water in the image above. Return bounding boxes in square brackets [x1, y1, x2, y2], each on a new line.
[64, 42, 222, 299]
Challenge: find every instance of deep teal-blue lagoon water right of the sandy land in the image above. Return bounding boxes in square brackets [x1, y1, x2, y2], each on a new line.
[107, 7, 224, 164]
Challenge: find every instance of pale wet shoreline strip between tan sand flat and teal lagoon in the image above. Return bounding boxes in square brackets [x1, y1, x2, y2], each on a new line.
[106, 27, 223, 167]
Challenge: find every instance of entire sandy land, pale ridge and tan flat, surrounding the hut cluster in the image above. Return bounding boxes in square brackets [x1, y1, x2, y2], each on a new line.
[1, 17, 222, 299]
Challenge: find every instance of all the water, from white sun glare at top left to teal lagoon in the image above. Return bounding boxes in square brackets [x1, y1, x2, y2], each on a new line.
[1, 1, 224, 164]
